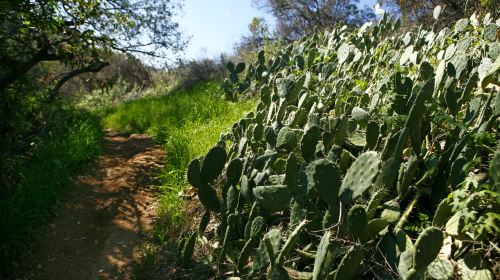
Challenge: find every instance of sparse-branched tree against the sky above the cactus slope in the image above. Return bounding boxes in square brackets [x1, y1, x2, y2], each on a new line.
[253, 0, 374, 41]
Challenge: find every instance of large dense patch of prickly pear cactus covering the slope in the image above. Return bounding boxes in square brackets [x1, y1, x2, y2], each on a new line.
[187, 8, 500, 279]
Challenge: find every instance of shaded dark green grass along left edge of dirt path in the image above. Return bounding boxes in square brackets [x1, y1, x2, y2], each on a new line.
[0, 110, 103, 278]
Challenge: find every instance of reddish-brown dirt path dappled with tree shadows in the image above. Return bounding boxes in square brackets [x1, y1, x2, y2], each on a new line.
[19, 131, 164, 279]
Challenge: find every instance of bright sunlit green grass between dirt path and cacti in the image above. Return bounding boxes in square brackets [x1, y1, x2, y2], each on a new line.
[104, 81, 255, 243]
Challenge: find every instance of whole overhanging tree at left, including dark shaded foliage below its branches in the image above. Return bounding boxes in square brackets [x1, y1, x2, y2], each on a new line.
[0, 0, 186, 199]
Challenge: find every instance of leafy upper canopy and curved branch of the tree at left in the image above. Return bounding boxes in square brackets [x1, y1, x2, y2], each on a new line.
[0, 0, 186, 95]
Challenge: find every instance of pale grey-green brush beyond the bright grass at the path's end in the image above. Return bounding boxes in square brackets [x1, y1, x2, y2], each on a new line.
[70, 55, 234, 110]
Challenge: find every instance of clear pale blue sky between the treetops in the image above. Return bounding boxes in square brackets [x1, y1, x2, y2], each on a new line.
[179, 0, 376, 59]
